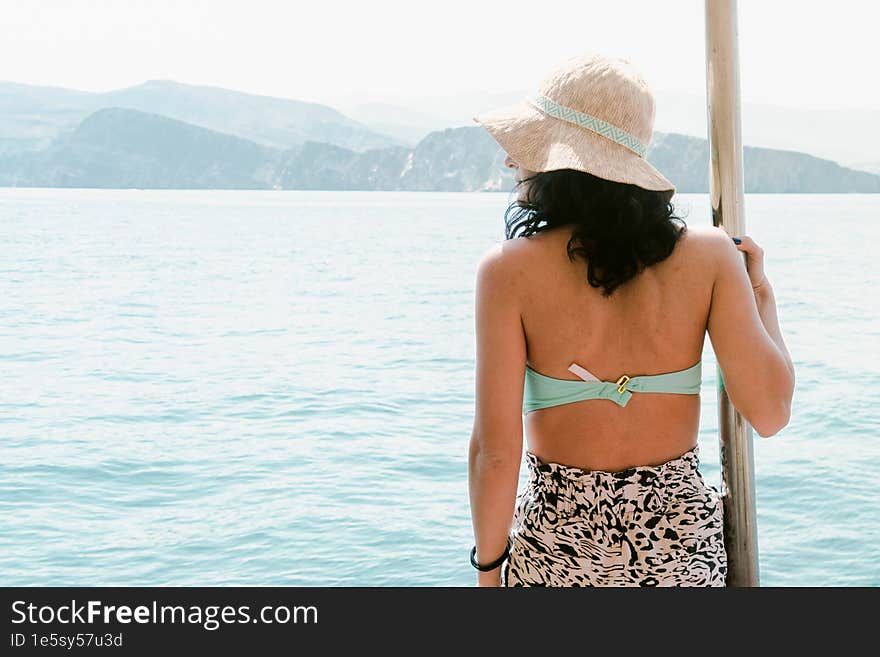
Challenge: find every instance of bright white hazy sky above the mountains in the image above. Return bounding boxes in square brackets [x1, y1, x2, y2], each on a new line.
[0, 0, 880, 109]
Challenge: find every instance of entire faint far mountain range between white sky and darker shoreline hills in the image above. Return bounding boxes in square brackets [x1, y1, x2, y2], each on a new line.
[0, 80, 880, 173]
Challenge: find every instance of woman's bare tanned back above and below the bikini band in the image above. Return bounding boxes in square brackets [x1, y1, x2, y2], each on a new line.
[516, 226, 715, 471]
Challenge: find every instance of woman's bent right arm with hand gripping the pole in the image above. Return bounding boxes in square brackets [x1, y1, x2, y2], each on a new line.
[707, 228, 795, 438]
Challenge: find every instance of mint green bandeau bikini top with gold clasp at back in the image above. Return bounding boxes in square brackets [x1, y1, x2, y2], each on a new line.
[523, 360, 702, 413]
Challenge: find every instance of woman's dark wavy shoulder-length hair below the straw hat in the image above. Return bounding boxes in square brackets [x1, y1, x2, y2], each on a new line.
[504, 169, 687, 297]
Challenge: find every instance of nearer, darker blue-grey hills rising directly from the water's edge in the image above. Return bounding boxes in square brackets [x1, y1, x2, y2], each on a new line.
[0, 101, 880, 193]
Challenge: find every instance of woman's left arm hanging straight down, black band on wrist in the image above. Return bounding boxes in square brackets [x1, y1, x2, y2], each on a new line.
[468, 242, 526, 586]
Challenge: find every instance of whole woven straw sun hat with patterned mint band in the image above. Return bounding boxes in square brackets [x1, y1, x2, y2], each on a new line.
[473, 53, 675, 193]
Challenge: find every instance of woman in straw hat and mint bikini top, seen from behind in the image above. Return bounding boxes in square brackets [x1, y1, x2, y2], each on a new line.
[469, 55, 795, 586]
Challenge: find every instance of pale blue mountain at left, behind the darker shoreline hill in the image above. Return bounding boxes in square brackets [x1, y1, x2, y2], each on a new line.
[0, 80, 398, 154]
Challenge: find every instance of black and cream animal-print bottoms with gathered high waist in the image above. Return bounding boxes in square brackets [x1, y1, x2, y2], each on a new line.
[501, 445, 727, 587]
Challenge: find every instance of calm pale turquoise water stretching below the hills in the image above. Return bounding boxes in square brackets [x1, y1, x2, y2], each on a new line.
[0, 188, 880, 586]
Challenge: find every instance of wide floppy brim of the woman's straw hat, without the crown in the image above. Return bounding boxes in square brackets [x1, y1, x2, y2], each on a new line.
[473, 100, 675, 193]
